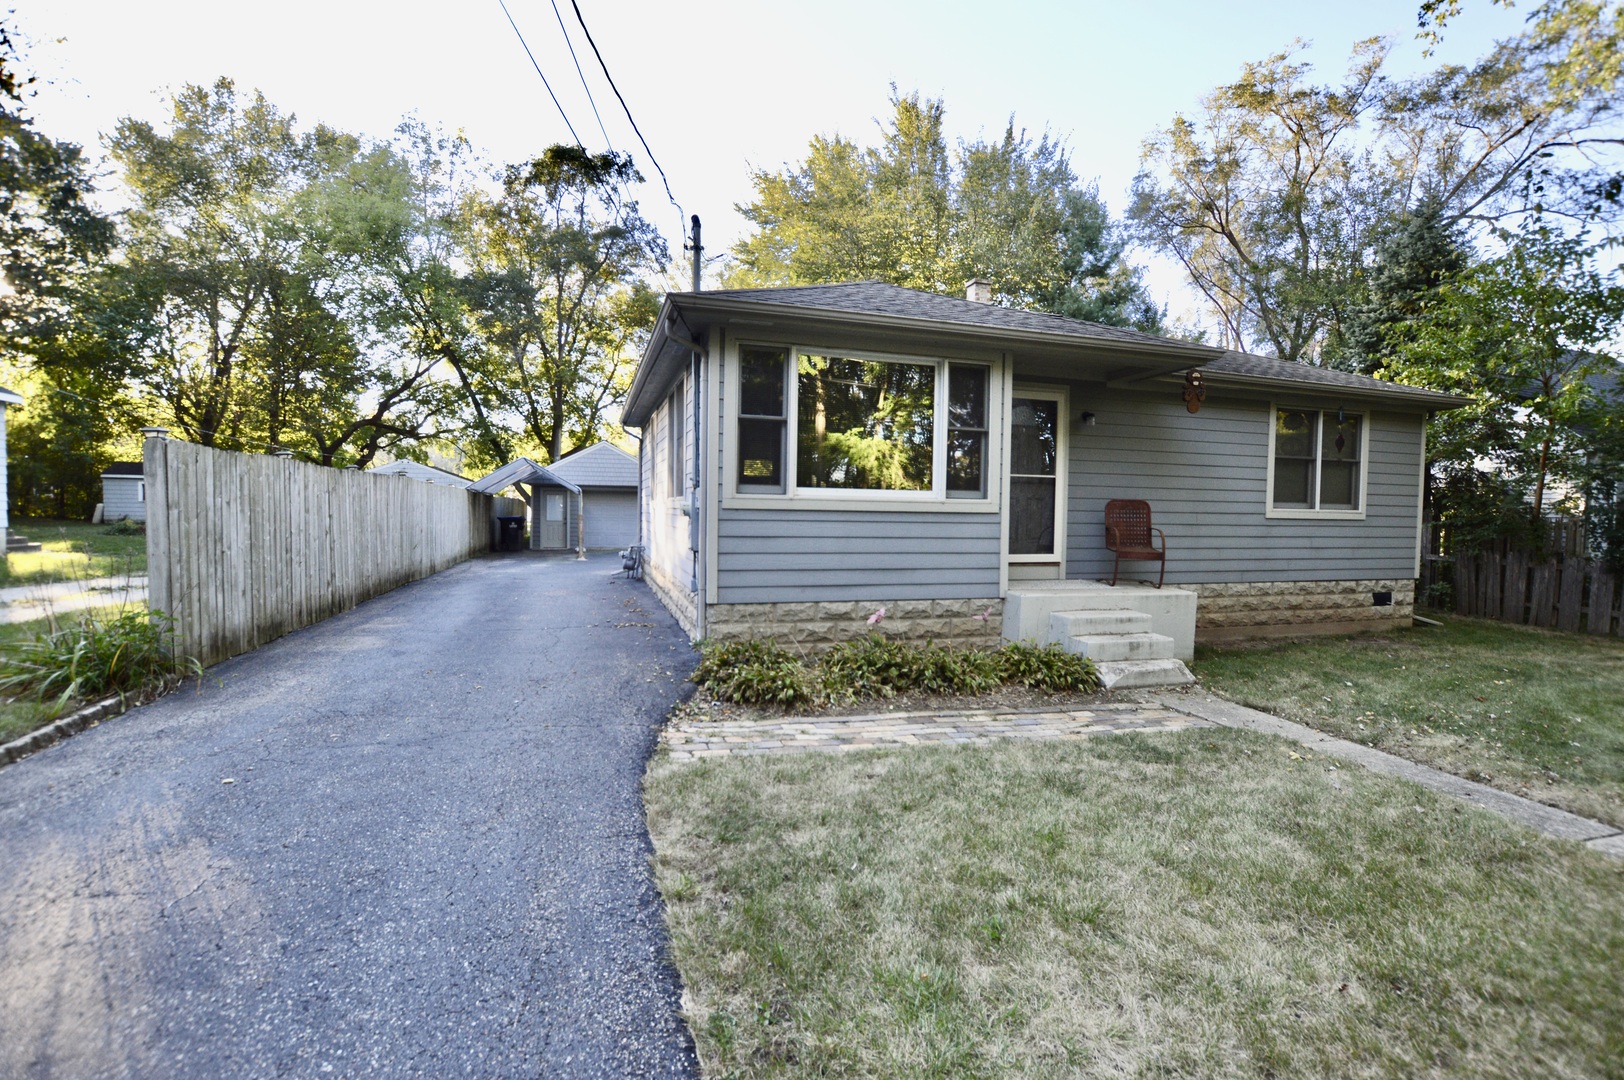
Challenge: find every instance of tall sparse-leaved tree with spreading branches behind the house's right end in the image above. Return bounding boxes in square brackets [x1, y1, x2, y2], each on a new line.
[1130, 23, 1618, 362]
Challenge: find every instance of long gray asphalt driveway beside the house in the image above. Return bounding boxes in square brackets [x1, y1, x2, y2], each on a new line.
[0, 557, 697, 1077]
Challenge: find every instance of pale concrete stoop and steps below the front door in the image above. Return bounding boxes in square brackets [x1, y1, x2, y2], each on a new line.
[1004, 581, 1195, 690]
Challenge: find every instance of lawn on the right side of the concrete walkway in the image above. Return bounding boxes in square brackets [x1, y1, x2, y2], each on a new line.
[1194, 619, 1624, 828]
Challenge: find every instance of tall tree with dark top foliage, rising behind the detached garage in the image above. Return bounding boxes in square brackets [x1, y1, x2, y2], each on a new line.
[468, 146, 669, 460]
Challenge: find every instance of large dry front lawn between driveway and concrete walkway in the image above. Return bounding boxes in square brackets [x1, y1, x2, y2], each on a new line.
[645, 729, 1624, 1077]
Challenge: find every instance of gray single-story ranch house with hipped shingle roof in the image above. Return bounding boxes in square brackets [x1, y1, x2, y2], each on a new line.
[624, 281, 1465, 685]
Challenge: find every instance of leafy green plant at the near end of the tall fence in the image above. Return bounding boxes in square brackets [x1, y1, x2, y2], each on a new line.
[0, 611, 197, 711]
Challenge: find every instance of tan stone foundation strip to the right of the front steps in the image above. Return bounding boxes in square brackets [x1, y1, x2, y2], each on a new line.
[1179, 578, 1416, 642]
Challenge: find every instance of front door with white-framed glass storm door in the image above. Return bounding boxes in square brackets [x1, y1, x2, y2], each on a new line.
[1007, 387, 1067, 580]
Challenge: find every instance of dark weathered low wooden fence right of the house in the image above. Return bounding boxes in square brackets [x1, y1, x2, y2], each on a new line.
[1455, 551, 1624, 635]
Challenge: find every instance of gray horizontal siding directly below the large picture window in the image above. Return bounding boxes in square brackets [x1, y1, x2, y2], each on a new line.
[716, 508, 1002, 604]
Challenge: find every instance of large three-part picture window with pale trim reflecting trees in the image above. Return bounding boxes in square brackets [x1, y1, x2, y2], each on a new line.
[736, 344, 991, 499]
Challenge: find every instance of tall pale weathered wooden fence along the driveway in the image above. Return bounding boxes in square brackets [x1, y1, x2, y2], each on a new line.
[145, 438, 513, 664]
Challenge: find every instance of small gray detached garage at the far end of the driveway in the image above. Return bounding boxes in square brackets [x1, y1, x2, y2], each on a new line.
[473, 442, 638, 551]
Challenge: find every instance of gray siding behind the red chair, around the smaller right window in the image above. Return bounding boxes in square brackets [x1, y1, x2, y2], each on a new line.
[1065, 385, 1423, 585]
